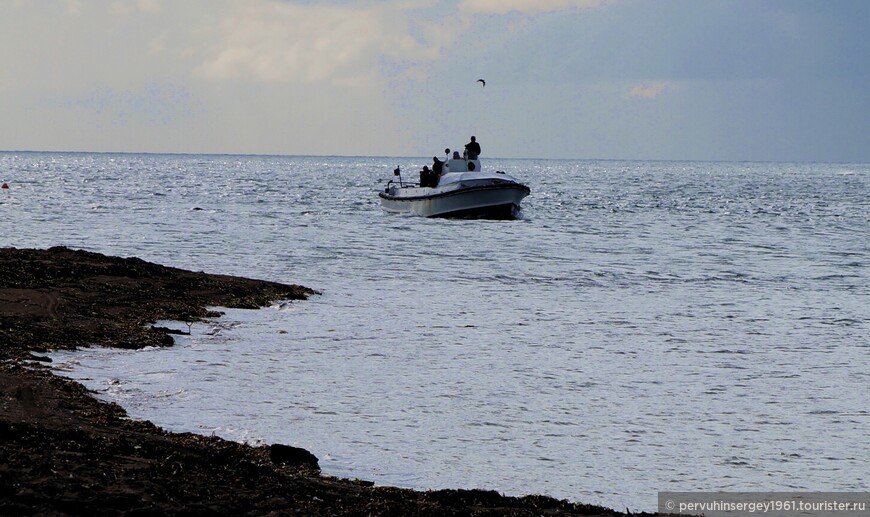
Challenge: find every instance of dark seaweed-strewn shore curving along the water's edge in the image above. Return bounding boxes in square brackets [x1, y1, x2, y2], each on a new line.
[0, 247, 648, 516]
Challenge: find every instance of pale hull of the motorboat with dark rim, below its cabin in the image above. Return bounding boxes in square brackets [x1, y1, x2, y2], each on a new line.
[380, 183, 529, 219]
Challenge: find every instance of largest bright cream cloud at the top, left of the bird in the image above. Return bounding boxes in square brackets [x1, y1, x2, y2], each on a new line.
[194, 0, 445, 83]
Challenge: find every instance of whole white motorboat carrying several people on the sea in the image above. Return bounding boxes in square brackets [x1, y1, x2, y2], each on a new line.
[380, 158, 531, 219]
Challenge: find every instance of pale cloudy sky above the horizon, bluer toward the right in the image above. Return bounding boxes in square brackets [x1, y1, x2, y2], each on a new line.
[0, 0, 870, 163]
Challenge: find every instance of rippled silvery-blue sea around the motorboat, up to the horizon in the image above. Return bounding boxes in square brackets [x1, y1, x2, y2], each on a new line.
[0, 152, 870, 511]
